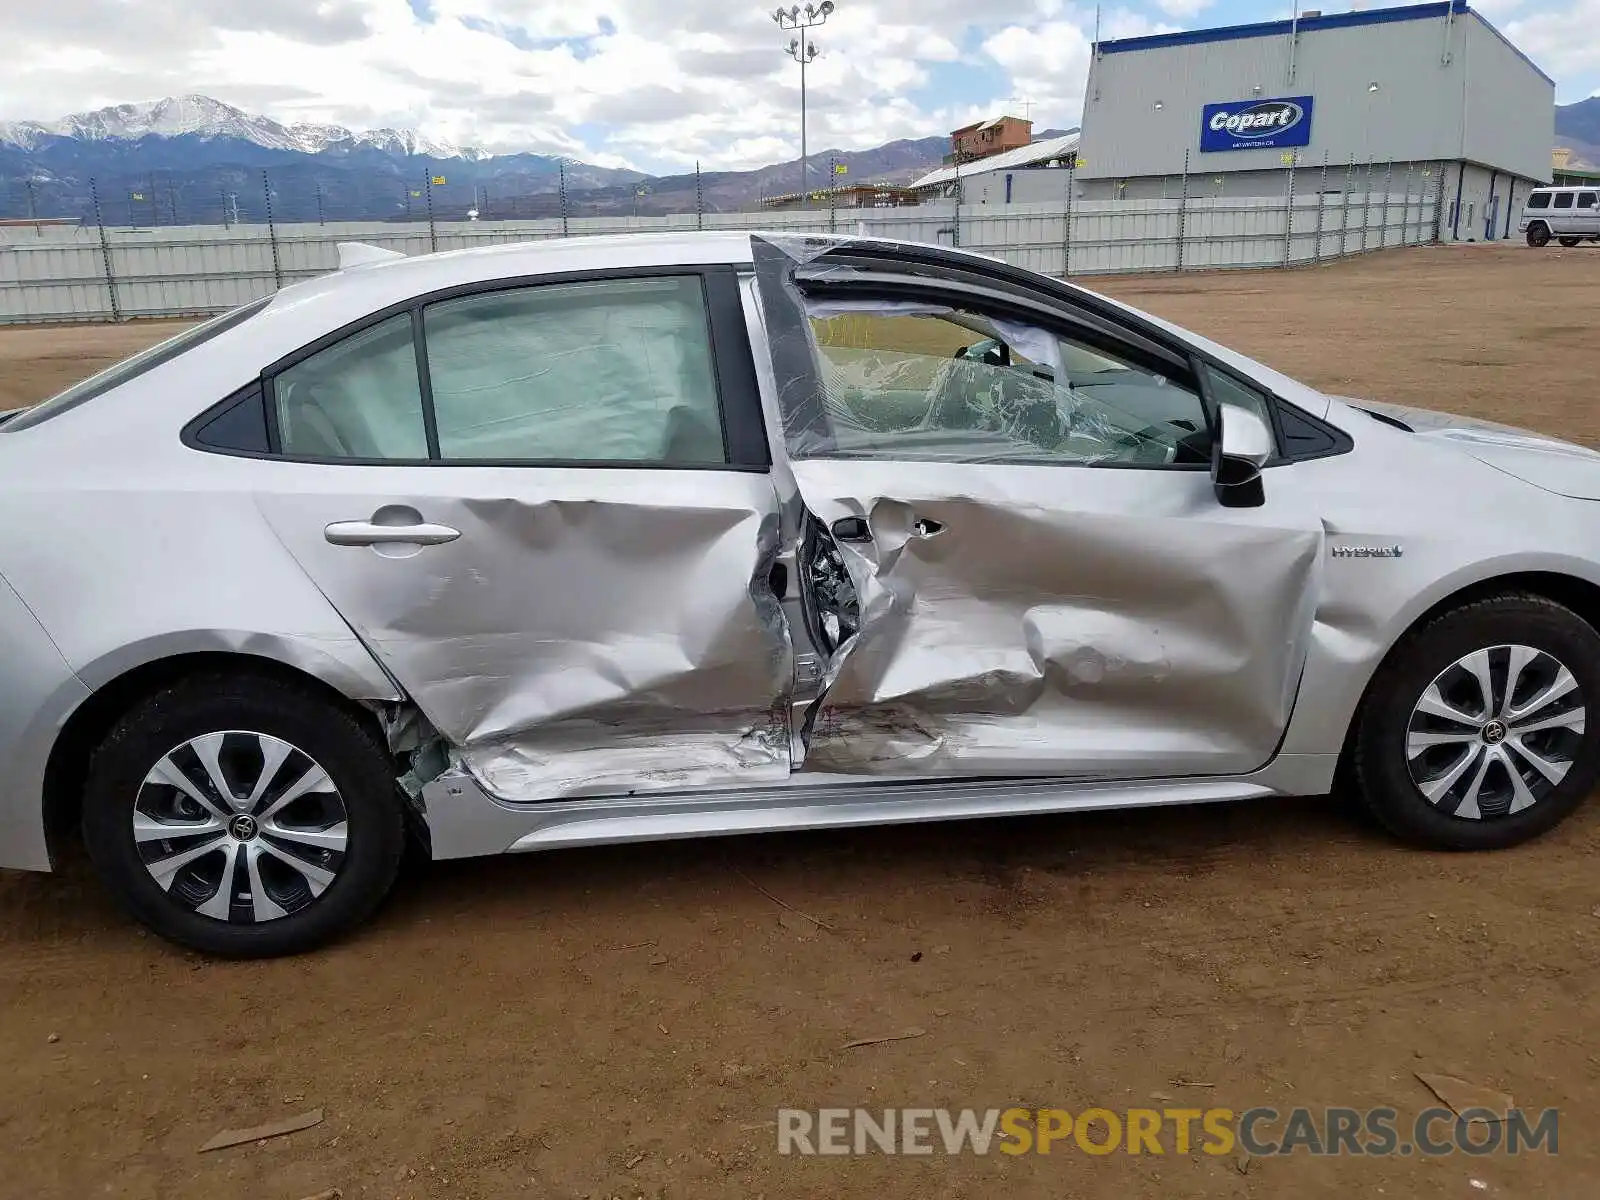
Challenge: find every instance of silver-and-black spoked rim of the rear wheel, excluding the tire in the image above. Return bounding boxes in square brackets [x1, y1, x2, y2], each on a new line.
[133, 730, 349, 923]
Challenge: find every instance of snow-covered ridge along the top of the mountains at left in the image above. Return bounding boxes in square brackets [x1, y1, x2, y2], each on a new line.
[0, 96, 490, 162]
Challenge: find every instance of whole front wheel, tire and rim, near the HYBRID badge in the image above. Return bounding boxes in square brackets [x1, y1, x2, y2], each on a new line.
[1355, 595, 1600, 850]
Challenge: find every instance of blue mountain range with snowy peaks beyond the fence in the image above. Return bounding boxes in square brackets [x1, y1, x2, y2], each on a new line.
[0, 96, 1600, 226]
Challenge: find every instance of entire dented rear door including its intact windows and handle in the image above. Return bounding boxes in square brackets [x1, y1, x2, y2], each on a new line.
[259, 267, 792, 802]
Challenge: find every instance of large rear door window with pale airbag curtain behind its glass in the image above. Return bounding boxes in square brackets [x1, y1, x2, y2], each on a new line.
[424, 275, 728, 466]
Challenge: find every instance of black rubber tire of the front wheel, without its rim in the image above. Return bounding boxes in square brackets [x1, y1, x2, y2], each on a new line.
[1354, 594, 1600, 850]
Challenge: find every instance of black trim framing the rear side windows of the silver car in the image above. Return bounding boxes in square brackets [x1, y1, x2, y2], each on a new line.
[179, 262, 771, 474]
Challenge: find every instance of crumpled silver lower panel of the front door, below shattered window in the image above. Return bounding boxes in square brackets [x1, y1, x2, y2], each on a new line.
[792, 459, 1322, 778]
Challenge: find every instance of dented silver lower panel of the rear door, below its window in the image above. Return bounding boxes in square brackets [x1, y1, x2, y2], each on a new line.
[261, 467, 794, 800]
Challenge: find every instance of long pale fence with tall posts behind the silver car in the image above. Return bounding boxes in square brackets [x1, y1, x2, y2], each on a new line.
[0, 163, 1443, 323]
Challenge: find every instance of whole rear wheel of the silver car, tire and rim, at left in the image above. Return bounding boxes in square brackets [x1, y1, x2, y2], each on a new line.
[83, 675, 405, 958]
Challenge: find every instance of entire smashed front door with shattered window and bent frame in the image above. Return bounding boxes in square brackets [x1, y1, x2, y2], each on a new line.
[755, 240, 1322, 779]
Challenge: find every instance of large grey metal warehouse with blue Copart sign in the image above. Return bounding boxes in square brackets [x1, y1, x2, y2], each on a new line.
[1075, 0, 1555, 242]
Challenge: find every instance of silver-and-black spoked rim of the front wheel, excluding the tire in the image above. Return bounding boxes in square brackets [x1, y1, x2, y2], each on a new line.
[1405, 645, 1587, 821]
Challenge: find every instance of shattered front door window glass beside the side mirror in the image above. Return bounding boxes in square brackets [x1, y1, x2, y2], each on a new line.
[811, 301, 1210, 467]
